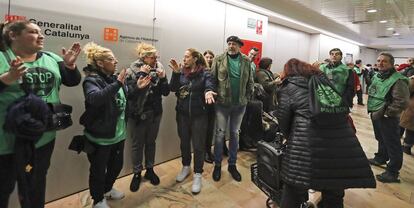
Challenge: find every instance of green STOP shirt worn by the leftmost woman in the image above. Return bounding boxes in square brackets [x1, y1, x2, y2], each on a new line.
[0, 49, 63, 155]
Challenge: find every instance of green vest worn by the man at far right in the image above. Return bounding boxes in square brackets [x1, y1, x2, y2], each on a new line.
[368, 72, 408, 112]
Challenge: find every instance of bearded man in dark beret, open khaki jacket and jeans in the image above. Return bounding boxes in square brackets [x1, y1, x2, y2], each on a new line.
[211, 36, 253, 181]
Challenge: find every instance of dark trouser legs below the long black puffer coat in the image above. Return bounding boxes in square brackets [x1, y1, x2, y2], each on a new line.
[280, 184, 345, 208]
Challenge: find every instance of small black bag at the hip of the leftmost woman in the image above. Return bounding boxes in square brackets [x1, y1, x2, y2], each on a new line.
[48, 103, 73, 130]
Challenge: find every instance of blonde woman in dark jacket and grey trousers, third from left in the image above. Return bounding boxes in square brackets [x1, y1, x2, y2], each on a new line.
[126, 43, 170, 192]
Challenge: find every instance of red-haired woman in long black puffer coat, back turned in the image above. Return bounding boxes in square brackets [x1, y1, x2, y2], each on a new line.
[277, 59, 376, 208]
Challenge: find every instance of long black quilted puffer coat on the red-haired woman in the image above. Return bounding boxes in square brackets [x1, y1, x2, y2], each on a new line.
[277, 77, 376, 190]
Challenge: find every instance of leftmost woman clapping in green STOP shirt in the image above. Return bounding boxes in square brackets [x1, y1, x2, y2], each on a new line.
[0, 20, 81, 208]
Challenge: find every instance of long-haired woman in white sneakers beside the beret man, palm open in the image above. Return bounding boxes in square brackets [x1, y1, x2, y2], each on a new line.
[169, 48, 216, 194]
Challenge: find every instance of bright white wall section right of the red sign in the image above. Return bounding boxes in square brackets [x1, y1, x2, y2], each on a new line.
[263, 23, 310, 72]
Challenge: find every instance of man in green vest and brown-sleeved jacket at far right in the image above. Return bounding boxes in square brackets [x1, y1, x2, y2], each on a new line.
[368, 53, 410, 183]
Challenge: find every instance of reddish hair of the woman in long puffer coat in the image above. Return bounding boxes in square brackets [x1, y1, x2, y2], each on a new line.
[280, 58, 322, 79]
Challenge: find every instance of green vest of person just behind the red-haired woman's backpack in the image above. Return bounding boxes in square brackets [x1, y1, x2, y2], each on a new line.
[320, 64, 349, 95]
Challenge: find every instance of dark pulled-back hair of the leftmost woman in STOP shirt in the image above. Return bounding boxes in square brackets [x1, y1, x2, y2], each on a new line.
[0, 20, 31, 51]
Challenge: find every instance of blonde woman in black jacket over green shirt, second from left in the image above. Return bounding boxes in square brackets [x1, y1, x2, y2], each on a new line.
[80, 42, 126, 208]
